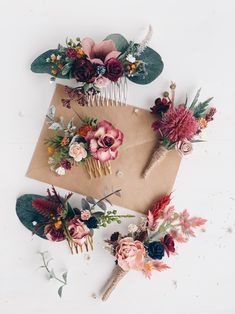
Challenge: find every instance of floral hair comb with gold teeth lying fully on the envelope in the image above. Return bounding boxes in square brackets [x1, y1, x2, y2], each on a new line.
[45, 105, 123, 178]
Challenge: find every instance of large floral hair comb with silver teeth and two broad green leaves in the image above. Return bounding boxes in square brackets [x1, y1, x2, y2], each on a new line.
[31, 26, 163, 106]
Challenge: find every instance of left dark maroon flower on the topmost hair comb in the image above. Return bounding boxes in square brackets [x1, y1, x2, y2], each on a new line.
[73, 59, 96, 83]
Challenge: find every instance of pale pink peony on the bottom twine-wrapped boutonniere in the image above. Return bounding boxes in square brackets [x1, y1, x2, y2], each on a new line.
[116, 237, 145, 271]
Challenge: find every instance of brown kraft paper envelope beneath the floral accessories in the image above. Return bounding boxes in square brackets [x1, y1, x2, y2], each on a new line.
[27, 85, 180, 213]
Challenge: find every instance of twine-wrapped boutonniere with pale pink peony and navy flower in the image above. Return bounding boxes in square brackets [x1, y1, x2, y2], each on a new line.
[102, 195, 206, 301]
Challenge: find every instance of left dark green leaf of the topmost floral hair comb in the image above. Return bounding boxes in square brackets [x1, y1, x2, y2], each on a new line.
[31, 49, 70, 79]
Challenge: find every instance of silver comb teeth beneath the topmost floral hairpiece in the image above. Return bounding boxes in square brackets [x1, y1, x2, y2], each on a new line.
[88, 77, 128, 107]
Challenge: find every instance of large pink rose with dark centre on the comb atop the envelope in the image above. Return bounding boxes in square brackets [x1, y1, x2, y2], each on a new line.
[86, 120, 123, 162]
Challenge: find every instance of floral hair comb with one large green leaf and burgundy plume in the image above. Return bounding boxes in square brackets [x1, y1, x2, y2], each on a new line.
[16, 187, 133, 254]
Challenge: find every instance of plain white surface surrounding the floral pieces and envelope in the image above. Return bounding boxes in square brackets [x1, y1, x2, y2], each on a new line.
[0, 0, 235, 314]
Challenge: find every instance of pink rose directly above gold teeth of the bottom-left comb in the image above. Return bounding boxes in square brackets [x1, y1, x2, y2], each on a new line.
[68, 217, 90, 246]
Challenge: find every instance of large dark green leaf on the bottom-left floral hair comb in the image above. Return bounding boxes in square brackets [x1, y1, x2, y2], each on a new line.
[16, 194, 47, 239]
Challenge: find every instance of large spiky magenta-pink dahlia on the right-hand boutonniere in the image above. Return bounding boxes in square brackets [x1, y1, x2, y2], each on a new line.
[153, 105, 198, 143]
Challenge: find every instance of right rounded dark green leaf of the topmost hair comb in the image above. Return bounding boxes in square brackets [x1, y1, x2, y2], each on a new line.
[127, 47, 164, 85]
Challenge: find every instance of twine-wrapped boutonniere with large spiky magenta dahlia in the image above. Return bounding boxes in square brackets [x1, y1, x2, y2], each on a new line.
[143, 83, 216, 178]
